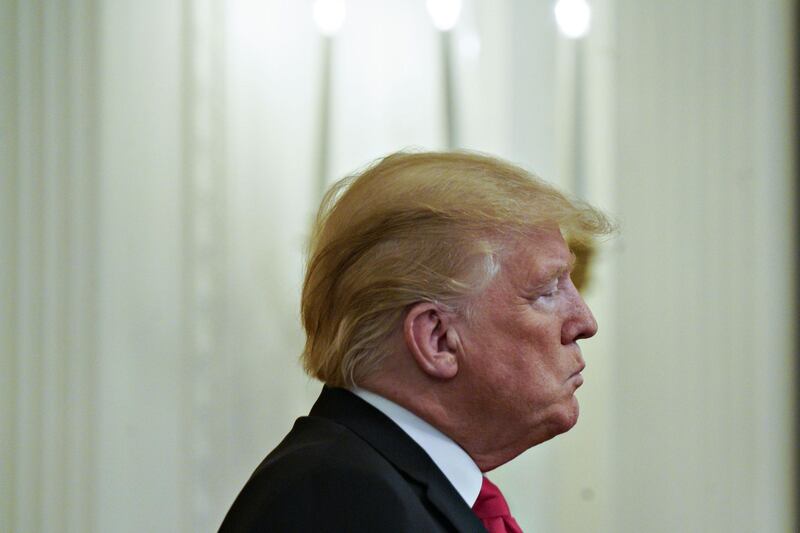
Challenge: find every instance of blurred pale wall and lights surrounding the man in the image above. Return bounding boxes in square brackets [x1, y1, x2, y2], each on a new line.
[0, 0, 798, 533]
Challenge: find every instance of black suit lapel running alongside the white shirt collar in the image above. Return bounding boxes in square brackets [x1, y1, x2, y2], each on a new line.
[310, 386, 486, 533]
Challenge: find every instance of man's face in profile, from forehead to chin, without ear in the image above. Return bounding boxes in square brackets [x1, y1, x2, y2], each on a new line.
[459, 229, 597, 456]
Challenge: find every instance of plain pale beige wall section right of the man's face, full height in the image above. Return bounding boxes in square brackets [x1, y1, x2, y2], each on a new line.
[612, 1, 796, 532]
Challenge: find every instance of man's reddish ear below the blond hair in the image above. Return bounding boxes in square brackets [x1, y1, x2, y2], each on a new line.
[403, 302, 460, 379]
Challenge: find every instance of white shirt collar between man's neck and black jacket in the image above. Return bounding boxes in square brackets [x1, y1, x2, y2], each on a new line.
[352, 388, 483, 507]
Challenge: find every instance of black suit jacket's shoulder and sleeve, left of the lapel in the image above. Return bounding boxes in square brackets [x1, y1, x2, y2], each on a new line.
[221, 418, 438, 531]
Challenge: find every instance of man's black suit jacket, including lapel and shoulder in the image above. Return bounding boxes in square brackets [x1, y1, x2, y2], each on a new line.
[220, 387, 486, 533]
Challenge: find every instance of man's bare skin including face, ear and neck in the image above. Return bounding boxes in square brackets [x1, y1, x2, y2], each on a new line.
[361, 229, 597, 471]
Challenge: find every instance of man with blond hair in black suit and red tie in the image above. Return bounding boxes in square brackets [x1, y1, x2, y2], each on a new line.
[221, 153, 611, 532]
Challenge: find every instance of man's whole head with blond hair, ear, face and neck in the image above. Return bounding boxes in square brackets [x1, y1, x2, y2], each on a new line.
[302, 153, 611, 466]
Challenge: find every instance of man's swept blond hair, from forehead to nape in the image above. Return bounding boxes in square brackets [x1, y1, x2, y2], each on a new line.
[301, 152, 613, 386]
